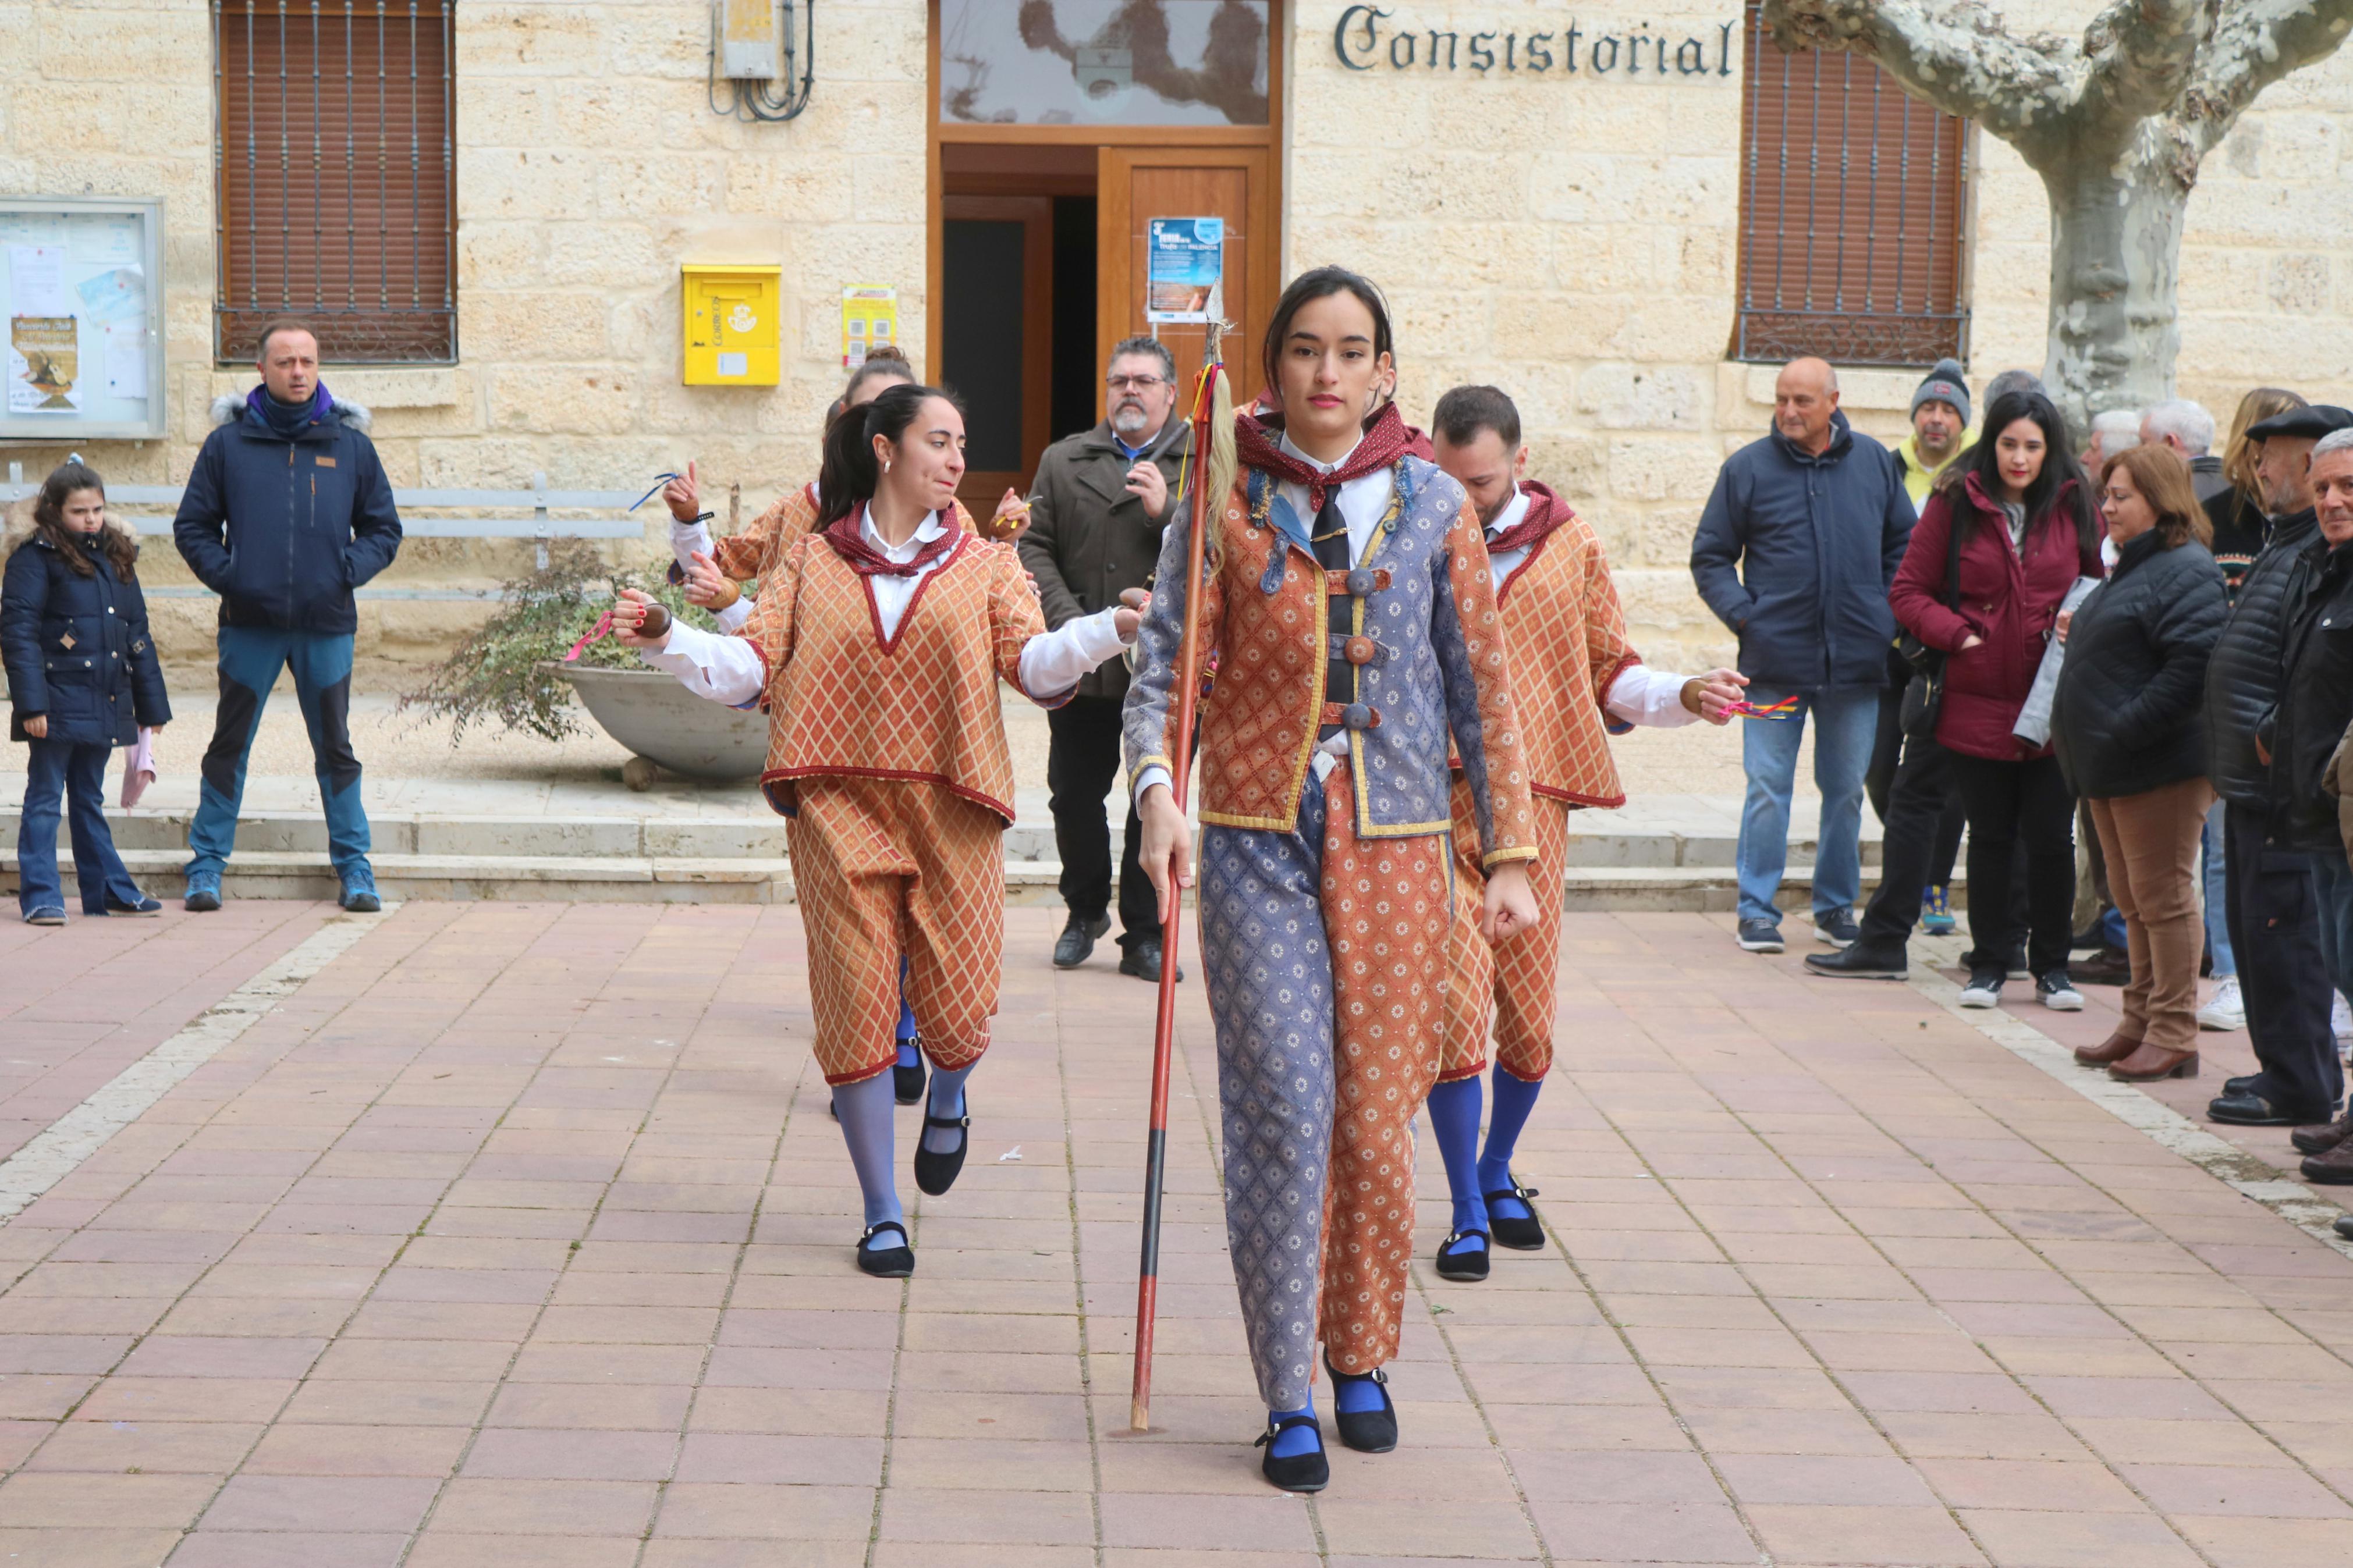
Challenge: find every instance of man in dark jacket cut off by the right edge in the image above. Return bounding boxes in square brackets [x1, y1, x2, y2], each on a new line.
[2259, 430, 2353, 1185]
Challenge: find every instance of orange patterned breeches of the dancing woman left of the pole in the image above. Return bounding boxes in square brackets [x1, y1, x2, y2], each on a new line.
[786, 778, 1005, 1084]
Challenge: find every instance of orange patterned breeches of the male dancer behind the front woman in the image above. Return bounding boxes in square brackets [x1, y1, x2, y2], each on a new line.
[1438, 778, 1570, 1084]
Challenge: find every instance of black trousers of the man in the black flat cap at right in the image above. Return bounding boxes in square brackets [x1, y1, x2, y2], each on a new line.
[2221, 802, 2344, 1121]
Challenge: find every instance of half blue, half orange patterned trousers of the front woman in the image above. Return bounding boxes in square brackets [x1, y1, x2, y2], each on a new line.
[1200, 764, 1447, 1410]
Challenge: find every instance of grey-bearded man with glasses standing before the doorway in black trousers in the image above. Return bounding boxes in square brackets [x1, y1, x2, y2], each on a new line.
[1019, 339, 1193, 983]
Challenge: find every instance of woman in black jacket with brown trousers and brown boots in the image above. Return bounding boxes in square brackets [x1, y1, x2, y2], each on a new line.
[2054, 447, 2226, 1082]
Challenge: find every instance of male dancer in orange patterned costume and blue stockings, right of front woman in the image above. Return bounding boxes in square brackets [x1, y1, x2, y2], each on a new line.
[1431, 386, 1741, 1279]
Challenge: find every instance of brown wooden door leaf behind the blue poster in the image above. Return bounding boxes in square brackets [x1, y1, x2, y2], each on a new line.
[1096, 143, 1282, 407]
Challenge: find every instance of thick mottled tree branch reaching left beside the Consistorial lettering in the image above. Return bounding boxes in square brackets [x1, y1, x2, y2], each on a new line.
[1765, 0, 2085, 158]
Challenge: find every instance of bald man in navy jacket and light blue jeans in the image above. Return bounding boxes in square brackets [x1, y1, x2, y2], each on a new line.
[1692, 360, 1913, 952]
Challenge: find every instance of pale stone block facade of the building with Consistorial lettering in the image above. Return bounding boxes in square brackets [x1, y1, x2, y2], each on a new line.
[0, 0, 2353, 677]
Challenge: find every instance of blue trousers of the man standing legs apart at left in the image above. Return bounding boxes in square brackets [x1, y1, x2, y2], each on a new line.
[188, 625, 370, 881]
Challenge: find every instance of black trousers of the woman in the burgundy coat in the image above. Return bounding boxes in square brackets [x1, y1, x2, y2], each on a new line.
[1946, 752, 2075, 976]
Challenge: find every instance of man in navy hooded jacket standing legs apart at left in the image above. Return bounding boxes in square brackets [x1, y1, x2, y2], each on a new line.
[172, 322, 400, 912]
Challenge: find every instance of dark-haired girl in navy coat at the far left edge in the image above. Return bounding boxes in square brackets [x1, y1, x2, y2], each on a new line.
[0, 458, 172, 926]
